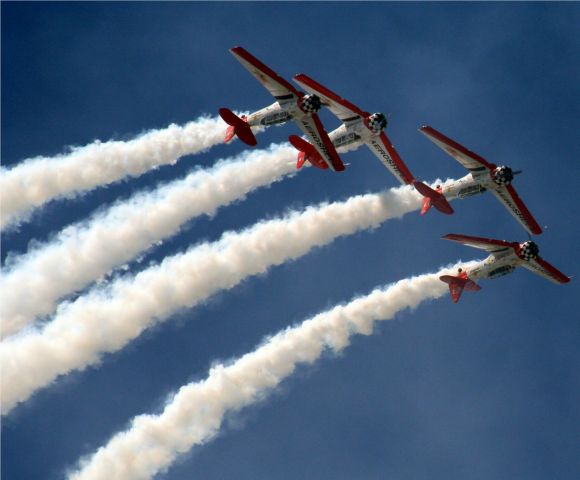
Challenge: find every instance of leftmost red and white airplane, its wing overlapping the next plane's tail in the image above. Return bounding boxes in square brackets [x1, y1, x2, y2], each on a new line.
[219, 47, 345, 172]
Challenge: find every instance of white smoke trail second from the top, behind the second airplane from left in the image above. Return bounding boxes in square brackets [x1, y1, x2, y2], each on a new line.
[0, 145, 296, 338]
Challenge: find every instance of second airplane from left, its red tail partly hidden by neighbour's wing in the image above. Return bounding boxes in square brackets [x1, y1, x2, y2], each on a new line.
[290, 73, 414, 185]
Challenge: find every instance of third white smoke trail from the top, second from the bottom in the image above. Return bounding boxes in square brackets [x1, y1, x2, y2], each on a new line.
[0, 182, 448, 414]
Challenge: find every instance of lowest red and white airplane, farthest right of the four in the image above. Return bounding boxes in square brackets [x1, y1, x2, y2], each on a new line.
[439, 233, 570, 303]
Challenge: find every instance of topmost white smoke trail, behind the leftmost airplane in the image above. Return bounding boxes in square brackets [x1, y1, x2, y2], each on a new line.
[0, 117, 231, 228]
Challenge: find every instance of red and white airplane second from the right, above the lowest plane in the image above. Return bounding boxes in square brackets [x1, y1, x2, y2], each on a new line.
[413, 126, 542, 235]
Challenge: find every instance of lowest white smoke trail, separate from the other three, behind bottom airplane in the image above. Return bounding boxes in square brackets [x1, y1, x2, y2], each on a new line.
[69, 266, 476, 480]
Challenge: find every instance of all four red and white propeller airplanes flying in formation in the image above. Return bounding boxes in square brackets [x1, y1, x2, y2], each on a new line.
[219, 47, 570, 303]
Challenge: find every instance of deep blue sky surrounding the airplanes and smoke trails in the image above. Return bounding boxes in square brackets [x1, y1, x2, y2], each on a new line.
[1, 2, 580, 480]
